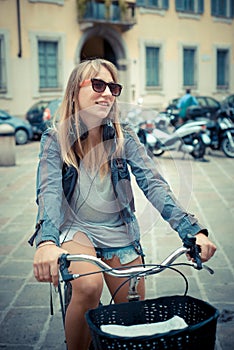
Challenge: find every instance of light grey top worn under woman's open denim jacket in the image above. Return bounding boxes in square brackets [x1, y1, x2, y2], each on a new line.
[60, 163, 131, 248]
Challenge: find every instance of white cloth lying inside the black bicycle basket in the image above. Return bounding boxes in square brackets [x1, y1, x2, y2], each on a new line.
[100, 316, 188, 337]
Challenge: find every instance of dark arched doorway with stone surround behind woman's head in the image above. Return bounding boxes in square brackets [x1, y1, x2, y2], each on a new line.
[76, 25, 130, 102]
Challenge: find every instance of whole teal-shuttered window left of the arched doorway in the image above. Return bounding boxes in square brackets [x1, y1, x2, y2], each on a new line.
[38, 40, 58, 89]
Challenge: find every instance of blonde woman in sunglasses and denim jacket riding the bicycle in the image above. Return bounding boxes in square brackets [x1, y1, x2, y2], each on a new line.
[31, 59, 216, 350]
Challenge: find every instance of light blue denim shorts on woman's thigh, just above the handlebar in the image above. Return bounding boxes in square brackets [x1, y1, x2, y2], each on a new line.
[95, 242, 144, 265]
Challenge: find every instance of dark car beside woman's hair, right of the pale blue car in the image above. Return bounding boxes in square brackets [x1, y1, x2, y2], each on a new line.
[25, 100, 49, 139]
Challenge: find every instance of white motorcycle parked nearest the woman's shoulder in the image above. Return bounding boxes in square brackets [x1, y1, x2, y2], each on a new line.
[138, 117, 210, 159]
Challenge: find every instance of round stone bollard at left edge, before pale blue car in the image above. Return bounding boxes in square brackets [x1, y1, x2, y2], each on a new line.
[0, 124, 15, 166]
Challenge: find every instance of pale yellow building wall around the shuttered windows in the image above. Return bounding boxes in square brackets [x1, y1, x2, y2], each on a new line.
[0, 0, 234, 116]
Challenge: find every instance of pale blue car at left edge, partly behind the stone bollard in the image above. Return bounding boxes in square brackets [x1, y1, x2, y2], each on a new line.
[0, 109, 33, 145]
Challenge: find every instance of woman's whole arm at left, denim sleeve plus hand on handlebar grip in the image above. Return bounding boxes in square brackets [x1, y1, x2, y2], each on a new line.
[33, 131, 67, 286]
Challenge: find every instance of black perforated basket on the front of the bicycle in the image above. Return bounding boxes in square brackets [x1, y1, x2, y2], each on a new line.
[86, 296, 219, 350]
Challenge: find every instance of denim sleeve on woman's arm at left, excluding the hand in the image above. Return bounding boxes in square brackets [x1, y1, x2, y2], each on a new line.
[36, 131, 65, 246]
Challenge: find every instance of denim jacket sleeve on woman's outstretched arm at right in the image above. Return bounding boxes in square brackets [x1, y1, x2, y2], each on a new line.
[122, 123, 208, 239]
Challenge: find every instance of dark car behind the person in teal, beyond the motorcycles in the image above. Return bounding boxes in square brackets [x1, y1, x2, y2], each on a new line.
[166, 96, 221, 119]
